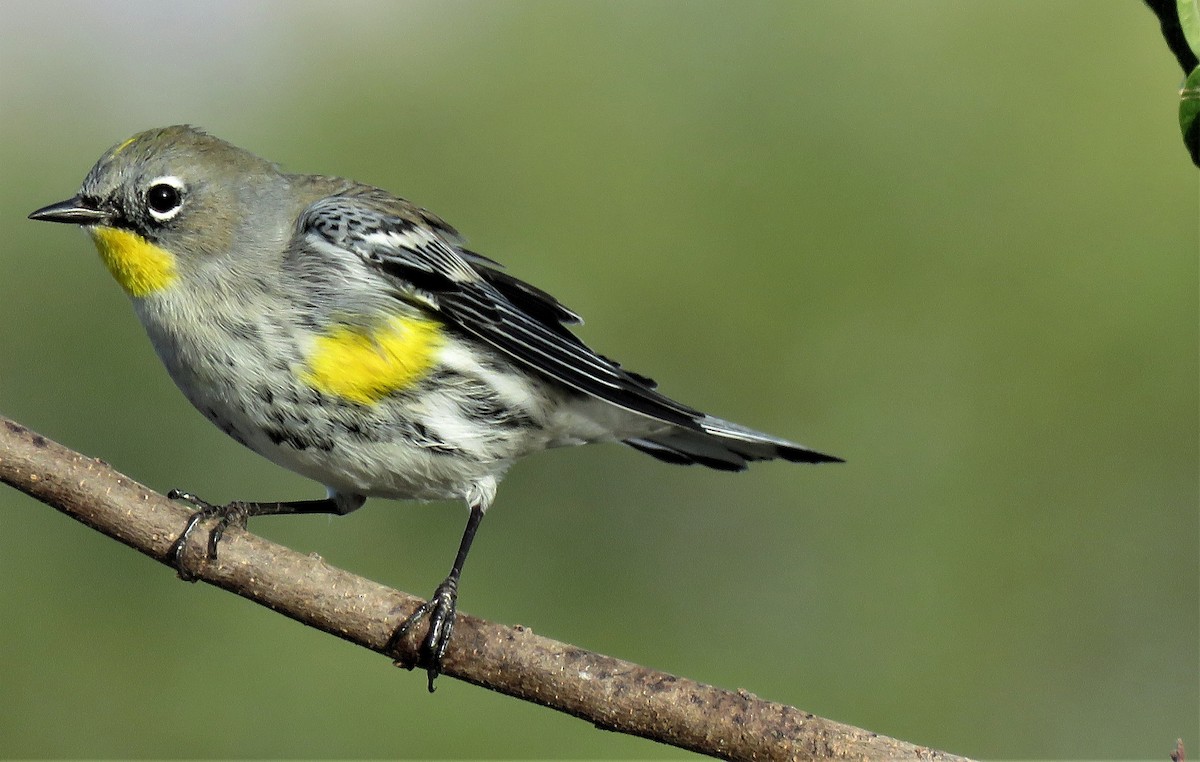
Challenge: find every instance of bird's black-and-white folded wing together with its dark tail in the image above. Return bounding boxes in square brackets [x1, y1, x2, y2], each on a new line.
[298, 193, 840, 470]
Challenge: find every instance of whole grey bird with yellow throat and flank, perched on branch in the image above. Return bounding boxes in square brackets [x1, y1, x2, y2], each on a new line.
[30, 126, 840, 690]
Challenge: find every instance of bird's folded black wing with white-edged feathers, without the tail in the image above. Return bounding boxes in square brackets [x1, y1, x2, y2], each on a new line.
[298, 188, 702, 430]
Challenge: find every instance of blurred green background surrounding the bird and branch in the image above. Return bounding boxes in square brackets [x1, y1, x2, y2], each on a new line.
[0, 0, 1200, 758]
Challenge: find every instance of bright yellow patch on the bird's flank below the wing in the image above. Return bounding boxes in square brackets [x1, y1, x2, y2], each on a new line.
[302, 317, 442, 404]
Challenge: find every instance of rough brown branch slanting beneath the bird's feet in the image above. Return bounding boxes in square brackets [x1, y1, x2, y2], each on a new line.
[0, 416, 962, 761]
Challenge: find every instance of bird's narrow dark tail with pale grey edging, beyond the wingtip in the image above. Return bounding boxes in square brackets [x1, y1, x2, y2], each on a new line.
[624, 415, 842, 470]
